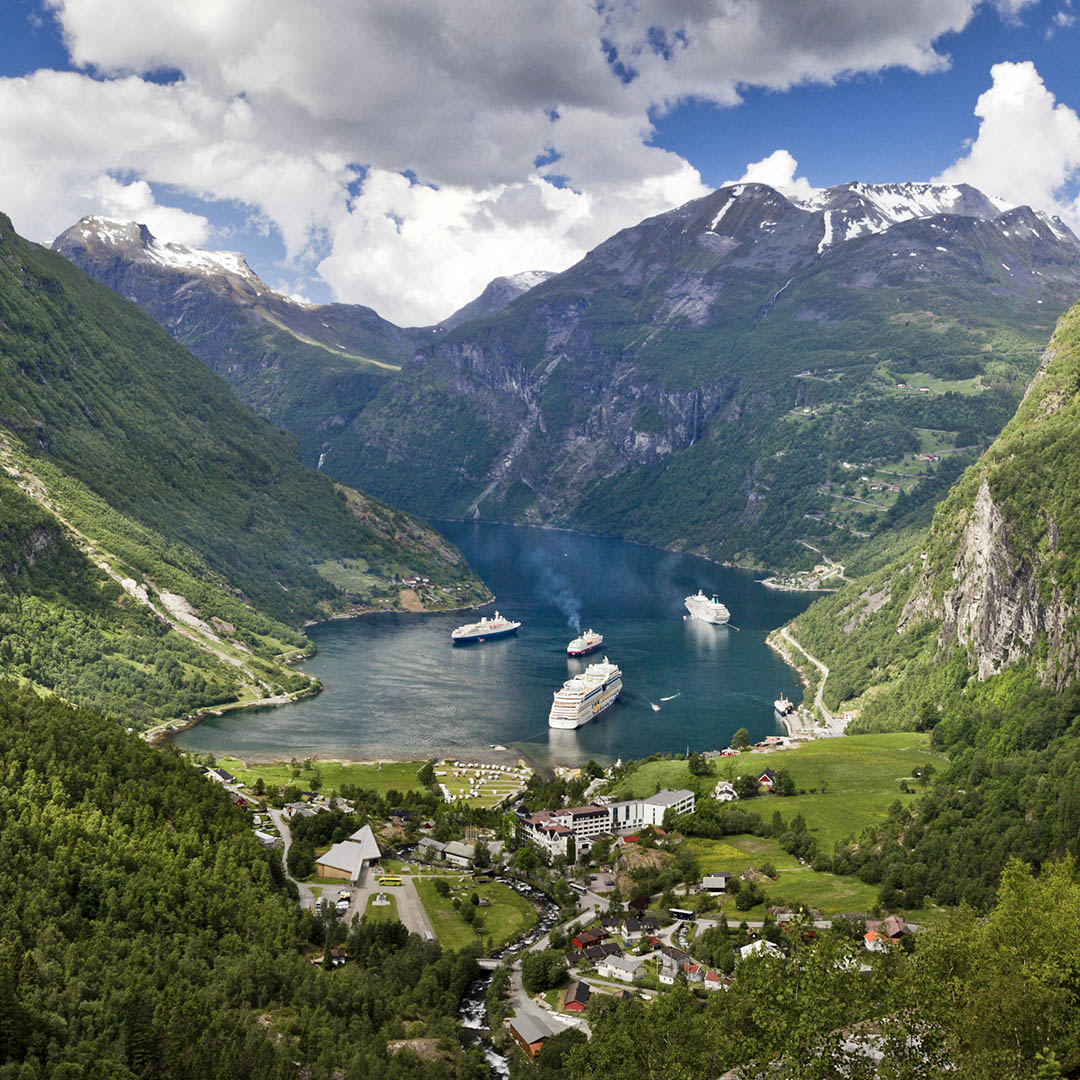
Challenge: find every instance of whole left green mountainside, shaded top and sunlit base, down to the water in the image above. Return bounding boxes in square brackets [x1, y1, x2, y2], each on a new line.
[0, 209, 486, 720]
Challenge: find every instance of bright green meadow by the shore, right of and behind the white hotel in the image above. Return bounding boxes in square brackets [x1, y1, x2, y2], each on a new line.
[618, 731, 942, 855]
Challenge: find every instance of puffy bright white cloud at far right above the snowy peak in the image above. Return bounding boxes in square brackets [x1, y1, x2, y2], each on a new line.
[936, 60, 1080, 228]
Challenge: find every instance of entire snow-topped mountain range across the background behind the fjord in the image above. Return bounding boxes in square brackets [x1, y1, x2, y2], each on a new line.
[54, 183, 1080, 568]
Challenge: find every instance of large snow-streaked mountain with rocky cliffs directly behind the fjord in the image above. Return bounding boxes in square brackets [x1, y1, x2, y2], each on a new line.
[335, 184, 1080, 564]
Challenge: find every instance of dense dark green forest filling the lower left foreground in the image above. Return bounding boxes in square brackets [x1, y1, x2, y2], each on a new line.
[0, 685, 483, 1080]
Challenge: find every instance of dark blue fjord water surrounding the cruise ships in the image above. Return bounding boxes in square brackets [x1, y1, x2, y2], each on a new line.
[175, 523, 812, 765]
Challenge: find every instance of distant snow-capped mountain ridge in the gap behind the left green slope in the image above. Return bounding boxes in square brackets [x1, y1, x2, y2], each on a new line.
[53, 217, 549, 473]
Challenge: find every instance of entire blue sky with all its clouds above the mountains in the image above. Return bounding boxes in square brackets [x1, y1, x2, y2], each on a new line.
[0, 0, 1080, 325]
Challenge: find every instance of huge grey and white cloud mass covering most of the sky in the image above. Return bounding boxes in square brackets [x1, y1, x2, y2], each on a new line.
[0, 0, 1024, 324]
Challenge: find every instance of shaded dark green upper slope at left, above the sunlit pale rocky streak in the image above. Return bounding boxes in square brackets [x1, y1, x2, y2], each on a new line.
[0, 210, 474, 623]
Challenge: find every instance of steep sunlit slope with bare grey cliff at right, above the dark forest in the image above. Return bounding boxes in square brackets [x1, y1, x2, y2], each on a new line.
[793, 305, 1080, 727]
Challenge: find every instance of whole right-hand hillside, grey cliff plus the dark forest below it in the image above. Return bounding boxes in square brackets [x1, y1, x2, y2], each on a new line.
[773, 306, 1080, 907]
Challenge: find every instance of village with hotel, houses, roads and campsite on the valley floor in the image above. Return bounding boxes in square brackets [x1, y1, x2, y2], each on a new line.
[192, 735, 922, 1057]
